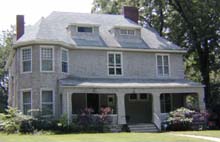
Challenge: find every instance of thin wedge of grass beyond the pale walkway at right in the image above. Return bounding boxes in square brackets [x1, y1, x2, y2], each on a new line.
[174, 130, 220, 138]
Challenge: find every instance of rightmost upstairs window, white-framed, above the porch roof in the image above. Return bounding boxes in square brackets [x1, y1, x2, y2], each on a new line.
[157, 55, 170, 76]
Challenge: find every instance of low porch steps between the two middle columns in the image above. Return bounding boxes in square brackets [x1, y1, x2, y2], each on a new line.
[128, 123, 158, 132]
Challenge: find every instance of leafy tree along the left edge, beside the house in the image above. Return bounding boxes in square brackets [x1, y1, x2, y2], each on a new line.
[0, 26, 15, 113]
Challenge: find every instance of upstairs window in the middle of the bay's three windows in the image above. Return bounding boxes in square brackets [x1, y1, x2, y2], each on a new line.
[41, 47, 54, 72]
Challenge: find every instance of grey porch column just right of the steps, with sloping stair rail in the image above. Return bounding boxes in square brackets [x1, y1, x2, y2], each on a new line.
[152, 92, 161, 129]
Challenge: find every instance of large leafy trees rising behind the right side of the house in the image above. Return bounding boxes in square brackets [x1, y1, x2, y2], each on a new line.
[92, 0, 220, 107]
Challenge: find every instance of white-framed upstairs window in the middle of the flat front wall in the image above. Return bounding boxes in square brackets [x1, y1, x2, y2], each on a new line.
[108, 53, 122, 76]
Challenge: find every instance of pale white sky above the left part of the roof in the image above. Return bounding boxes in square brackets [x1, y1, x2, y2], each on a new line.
[0, 0, 93, 32]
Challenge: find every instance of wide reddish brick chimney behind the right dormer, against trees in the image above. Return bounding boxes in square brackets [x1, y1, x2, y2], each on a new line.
[123, 6, 139, 23]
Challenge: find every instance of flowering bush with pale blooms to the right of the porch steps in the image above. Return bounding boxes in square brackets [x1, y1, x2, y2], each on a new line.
[166, 107, 208, 131]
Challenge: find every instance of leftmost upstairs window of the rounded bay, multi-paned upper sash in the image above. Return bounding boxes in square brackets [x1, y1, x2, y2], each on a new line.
[21, 48, 32, 73]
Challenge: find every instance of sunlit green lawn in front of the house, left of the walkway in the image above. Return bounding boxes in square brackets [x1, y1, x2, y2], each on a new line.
[0, 133, 214, 142]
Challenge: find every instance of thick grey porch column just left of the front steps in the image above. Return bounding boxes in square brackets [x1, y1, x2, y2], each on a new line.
[116, 93, 126, 124]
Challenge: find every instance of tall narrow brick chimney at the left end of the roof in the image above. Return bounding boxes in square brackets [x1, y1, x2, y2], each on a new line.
[16, 15, 24, 40]
